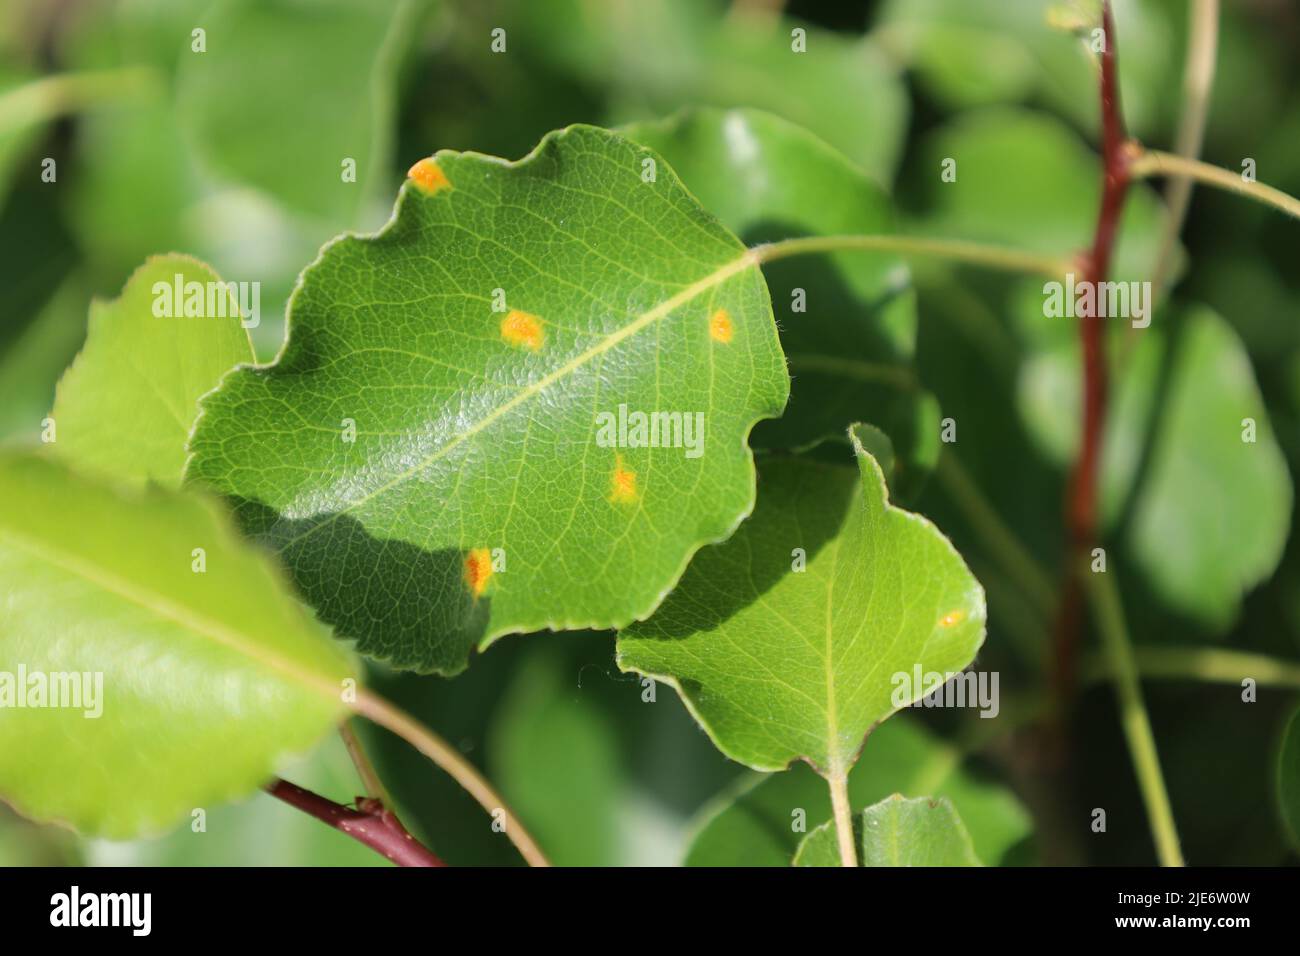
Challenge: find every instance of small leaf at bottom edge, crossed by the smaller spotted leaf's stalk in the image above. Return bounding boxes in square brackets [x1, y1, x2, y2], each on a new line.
[794, 793, 980, 866]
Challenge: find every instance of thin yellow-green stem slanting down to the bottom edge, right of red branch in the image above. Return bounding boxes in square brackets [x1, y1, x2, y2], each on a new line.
[1080, 570, 1183, 866]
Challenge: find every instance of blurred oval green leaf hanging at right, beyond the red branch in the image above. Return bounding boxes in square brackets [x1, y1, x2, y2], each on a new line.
[1128, 308, 1294, 631]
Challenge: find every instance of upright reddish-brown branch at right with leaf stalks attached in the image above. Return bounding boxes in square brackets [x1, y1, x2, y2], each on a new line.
[1054, 0, 1134, 702]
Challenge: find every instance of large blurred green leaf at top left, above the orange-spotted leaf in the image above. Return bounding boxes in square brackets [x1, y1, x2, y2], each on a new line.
[177, 0, 423, 228]
